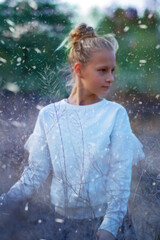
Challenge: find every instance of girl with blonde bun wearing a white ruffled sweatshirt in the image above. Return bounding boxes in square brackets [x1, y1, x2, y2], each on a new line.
[1, 24, 144, 240]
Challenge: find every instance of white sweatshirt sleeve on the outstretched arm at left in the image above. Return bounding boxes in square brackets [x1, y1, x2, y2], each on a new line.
[7, 109, 51, 202]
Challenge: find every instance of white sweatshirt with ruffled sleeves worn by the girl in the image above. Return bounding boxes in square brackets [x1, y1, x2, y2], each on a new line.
[7, 98, 145, 236]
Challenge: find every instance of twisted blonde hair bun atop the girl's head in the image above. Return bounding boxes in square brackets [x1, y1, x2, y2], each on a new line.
[69, 23, 97, 45]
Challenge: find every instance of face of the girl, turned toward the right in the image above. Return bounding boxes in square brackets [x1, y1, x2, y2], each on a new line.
[77, 49, 116, 96]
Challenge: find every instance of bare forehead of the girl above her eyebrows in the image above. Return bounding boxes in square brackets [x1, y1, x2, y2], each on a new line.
[90, 49, 116, 65]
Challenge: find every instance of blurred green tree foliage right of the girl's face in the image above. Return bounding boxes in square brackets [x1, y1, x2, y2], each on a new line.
[97, 8, 160, 93]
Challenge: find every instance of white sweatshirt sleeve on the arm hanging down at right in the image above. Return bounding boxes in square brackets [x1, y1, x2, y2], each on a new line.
[99, 106, 145, 237]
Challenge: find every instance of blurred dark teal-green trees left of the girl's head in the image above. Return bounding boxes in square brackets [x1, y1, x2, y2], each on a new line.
[0, 0, 72, 93]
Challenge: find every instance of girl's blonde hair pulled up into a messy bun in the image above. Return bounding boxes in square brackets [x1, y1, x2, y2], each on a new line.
[56, 23, 119, 90]
